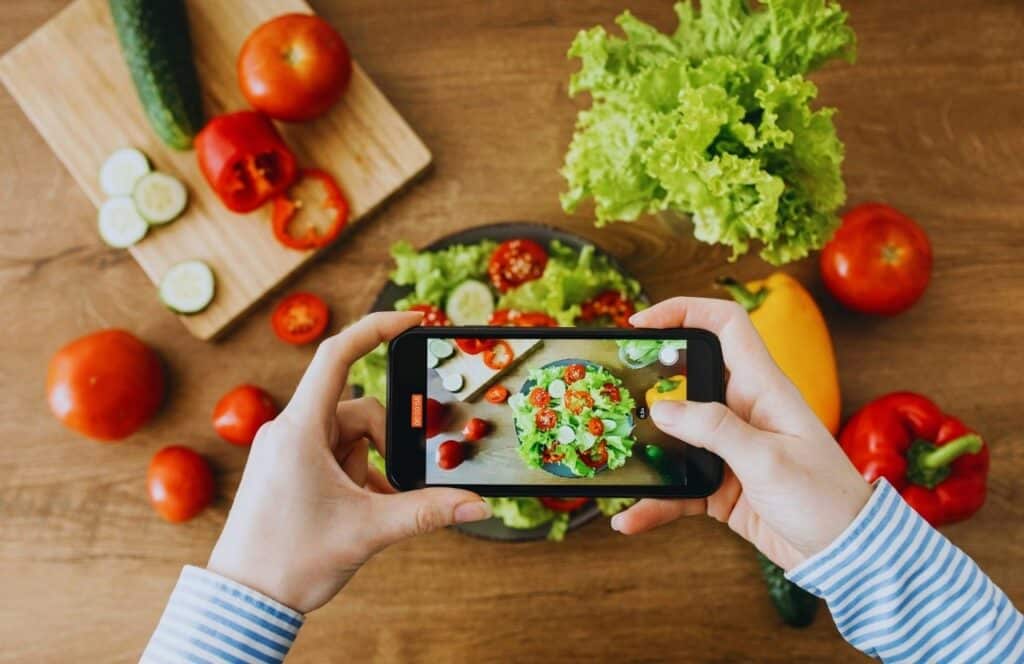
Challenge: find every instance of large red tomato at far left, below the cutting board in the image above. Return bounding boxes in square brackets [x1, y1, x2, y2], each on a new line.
[46, 330, 164, 441]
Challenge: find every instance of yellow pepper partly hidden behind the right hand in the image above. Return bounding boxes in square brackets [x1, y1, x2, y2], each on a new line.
[719, 273, 841, 434]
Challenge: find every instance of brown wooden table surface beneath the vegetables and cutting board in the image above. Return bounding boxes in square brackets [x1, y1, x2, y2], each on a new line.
[0, 0, 1024, 662]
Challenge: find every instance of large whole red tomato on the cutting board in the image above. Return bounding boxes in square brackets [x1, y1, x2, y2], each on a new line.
[238, 13, 352, 122]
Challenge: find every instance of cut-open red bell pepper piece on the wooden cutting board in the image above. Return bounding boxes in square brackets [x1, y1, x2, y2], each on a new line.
[196, 111, 295, 212]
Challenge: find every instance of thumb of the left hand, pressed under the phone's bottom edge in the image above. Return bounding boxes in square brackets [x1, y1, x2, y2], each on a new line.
[371, 488, 490, 549]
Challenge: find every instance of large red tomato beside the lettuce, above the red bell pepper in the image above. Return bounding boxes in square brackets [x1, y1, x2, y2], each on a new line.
[821, 203, 932, 316]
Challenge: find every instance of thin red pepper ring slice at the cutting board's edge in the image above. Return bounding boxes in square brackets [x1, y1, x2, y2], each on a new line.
[271, 168, 348, 250]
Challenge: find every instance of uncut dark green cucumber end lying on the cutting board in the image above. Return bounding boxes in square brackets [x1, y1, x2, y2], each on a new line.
[110, 0, 203, 150]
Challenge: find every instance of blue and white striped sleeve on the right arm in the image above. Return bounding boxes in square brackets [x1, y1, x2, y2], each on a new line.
[786, 480, 1024, 662]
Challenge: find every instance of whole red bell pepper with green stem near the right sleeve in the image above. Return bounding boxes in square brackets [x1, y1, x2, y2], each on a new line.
[839, 392, 988, 526]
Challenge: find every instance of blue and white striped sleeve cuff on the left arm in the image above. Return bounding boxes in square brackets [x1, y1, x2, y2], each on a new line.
[140, 566, 303, 664]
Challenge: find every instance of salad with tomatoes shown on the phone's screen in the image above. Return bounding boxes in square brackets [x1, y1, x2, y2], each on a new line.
[509, 364, 636, 478]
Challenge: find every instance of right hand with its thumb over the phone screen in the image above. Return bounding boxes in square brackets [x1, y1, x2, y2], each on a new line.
[611, 297, 871, 570]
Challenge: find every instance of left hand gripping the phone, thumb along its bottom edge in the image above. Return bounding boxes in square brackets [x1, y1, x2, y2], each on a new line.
[207, 313, 490, 613]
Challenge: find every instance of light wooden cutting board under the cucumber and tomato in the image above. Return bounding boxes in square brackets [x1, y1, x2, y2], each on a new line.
[0, 0, 430, 339]
